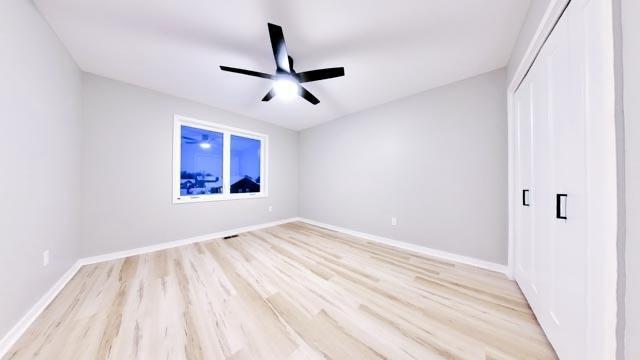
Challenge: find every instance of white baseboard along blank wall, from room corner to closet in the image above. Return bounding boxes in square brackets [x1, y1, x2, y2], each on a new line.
[298, 218, 508, 275]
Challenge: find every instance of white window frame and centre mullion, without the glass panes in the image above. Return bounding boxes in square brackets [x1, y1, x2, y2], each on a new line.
[173, 114, 269, 204]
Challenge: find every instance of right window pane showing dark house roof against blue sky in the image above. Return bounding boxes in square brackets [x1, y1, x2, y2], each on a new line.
[231, 135, 260, 194]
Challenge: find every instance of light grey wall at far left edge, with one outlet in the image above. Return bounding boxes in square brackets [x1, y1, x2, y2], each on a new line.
[0, 0, 82, 338]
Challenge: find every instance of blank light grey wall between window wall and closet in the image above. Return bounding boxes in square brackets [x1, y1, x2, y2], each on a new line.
[299, 70, 507, 264]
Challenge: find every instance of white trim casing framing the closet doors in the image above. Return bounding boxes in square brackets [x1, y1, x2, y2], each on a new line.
[507, 0, 618, 359]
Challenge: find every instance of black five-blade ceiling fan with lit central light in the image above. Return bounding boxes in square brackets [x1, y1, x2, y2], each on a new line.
[220, 23, 344, 105]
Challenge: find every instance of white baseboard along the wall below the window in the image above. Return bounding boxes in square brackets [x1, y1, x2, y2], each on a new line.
[79, 217, 299, 265]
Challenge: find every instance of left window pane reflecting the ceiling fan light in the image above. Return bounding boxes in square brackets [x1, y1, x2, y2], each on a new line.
[180, 125, 223, 196]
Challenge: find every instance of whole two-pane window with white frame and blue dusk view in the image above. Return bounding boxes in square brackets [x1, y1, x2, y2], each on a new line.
[173, 115, 267, 203]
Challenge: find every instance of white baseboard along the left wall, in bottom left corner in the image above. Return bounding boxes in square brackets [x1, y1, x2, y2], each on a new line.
[0, 261, 82, 358]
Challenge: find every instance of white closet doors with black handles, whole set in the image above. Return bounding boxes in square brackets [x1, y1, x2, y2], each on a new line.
[514, 0, 615, 359]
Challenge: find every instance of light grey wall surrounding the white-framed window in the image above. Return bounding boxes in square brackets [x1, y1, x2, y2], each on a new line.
[81, 74, 298, 256]
